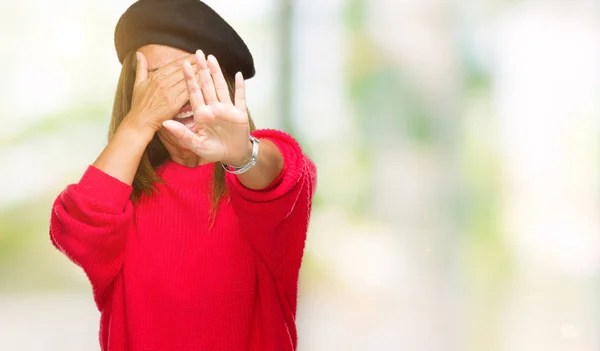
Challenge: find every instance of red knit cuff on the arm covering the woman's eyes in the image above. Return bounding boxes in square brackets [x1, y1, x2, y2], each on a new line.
[79, 165, 133, 208]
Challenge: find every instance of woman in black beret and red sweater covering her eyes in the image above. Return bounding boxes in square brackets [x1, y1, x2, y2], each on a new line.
[50, 0, 316, 351]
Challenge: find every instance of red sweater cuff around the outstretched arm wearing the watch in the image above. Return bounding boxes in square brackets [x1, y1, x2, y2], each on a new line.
[225, 129, 304, 202]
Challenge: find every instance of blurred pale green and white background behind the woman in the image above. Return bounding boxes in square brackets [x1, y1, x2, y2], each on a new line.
[0, 0, 600, 351]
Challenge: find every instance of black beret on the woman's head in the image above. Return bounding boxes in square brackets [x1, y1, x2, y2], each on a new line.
[115, 0, 255, 79]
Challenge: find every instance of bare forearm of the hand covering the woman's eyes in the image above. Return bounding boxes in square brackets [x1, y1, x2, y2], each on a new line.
[94, 117, 154, 185]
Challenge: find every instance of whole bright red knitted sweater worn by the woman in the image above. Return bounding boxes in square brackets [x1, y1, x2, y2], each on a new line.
[50, 130, 316, 351]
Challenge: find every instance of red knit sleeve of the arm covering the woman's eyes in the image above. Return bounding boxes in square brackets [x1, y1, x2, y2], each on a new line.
[50, 166, 133, 310]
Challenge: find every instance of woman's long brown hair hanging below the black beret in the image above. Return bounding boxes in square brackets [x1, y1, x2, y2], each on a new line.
[108, 51, 256, 213]
